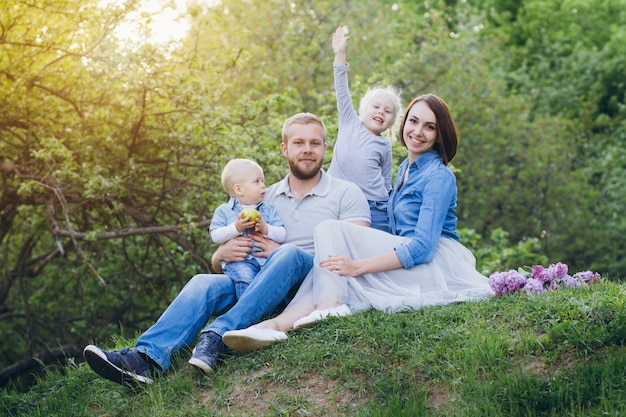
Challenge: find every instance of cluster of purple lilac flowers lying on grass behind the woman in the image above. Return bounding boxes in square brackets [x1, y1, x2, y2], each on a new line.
[489, 262, 600, 295]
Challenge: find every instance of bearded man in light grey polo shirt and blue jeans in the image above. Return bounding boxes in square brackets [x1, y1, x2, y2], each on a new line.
[84, 113, 370, 385]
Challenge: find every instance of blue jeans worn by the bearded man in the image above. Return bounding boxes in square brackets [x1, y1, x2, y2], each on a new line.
[135, 244, 313, 371]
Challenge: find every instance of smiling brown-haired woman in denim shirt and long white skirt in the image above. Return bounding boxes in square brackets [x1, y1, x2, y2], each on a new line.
[223, 94, 493, 352]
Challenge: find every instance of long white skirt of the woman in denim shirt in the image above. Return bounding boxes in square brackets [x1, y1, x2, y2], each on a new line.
[287, 220, 494, 313]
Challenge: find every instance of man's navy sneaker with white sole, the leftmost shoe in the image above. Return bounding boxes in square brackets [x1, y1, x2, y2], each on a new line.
[83, 345, 154, 386]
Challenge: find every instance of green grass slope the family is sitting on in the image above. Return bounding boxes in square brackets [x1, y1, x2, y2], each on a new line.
[0, 282, 626, 417]
